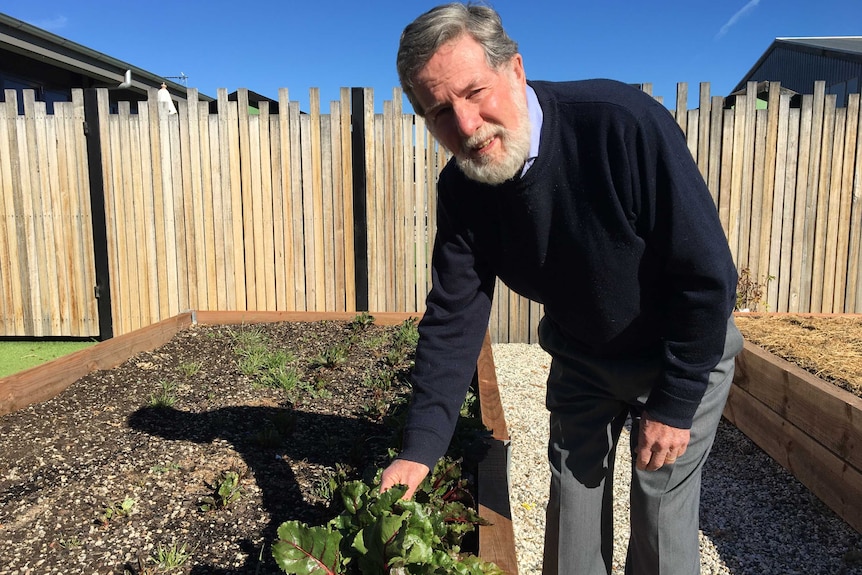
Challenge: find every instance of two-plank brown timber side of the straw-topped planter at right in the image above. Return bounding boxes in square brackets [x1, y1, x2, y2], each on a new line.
[724, 342, 862, 532]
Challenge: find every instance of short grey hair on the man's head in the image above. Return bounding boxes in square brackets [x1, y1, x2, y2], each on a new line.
[396, 3, 518, 116]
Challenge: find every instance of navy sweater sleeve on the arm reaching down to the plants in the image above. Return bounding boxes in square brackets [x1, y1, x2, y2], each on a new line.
[399, 178, 494, 469]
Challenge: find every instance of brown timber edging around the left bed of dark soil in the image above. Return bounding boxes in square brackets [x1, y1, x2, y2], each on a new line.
[0, 311, 518, 575]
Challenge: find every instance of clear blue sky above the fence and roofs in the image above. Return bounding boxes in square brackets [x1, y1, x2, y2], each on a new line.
[0, 0, 862, 111]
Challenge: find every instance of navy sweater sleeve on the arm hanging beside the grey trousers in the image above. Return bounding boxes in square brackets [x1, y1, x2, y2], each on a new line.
[641, 103, 737, 428]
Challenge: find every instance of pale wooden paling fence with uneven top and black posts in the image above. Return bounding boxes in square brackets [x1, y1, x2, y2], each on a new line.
[0, 83, 862, 342]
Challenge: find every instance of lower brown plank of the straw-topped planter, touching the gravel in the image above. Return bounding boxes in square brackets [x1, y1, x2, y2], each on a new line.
[724, 386, 862, 531]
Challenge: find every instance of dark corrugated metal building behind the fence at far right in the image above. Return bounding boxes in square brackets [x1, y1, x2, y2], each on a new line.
[732, 36, 862, 98]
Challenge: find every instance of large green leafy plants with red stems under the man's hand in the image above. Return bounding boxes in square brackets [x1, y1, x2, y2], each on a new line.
[272, 458, 503, 575]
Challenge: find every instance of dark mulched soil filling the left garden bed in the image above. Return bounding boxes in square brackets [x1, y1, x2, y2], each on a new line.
[0, 321, 422, 575]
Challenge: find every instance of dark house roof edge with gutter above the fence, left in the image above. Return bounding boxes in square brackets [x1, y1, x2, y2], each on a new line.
[0, 13, 213, 101]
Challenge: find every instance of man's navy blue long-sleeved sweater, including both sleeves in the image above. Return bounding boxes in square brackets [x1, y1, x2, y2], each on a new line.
[400, 80, 737, 467]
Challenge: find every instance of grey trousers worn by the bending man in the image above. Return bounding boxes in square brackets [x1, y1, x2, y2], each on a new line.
[539, 317, 743, 575]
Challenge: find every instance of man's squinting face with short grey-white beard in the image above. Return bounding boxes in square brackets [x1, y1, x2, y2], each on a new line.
[414, 34, 530, 184]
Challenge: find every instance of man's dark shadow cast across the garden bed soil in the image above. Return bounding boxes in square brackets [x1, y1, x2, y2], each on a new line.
[128, 406, 393, 575]
